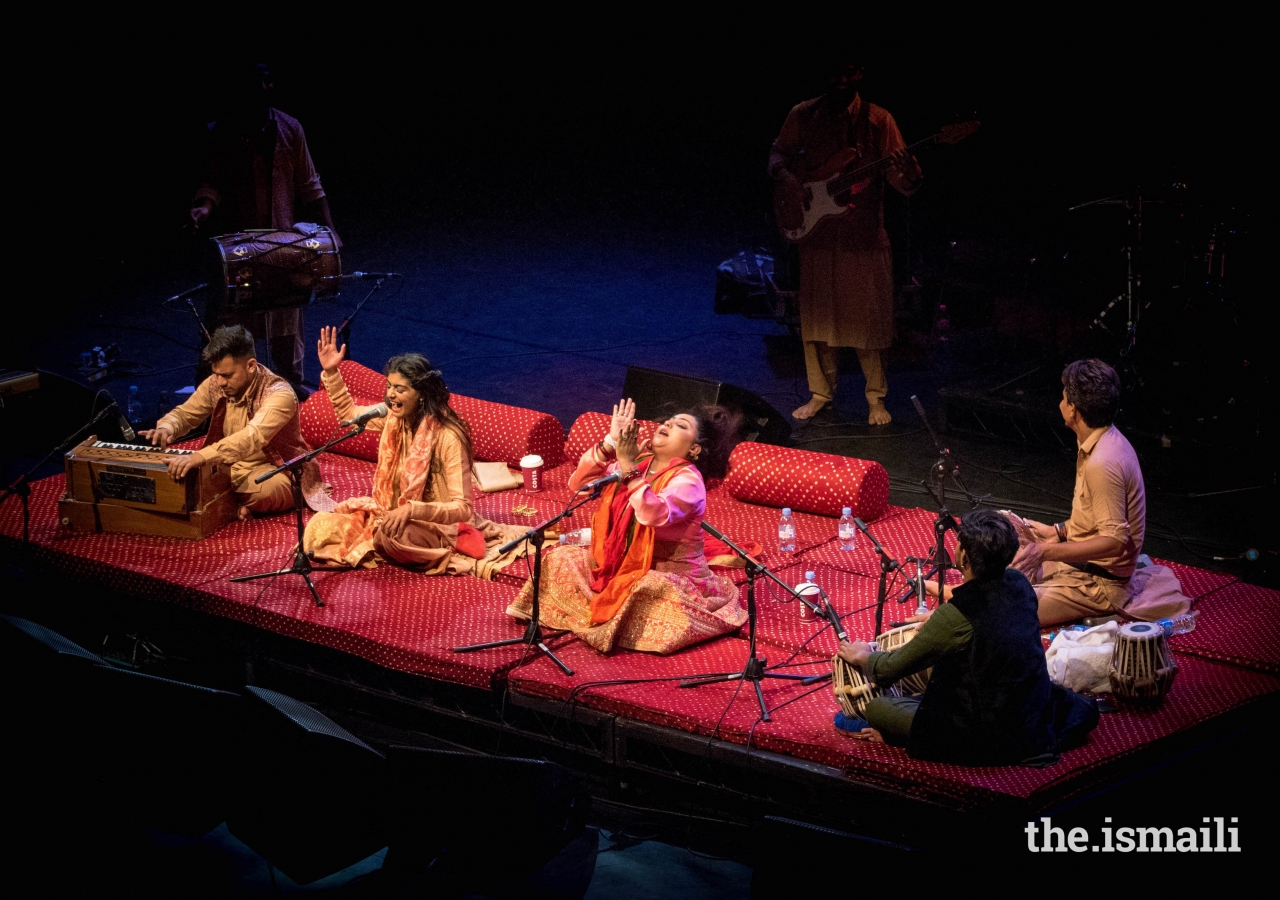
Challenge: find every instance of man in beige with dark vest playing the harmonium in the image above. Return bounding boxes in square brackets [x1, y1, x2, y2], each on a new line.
[141, 325, 333, 521]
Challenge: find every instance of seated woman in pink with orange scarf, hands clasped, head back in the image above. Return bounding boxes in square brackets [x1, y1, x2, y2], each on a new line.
[507, 399, 746, 653]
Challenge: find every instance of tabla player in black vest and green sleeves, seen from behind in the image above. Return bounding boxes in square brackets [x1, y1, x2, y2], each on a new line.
[836, 510, 1098, 766]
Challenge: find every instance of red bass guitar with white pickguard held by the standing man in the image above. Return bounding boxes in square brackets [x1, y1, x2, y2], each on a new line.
[773, 120, 978, 243]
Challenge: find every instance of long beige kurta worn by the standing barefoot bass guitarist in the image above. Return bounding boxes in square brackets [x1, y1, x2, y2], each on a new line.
[769, 96, 918, 350]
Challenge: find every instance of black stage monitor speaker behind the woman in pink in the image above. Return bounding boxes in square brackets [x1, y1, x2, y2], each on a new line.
[622, 366, 791, 444]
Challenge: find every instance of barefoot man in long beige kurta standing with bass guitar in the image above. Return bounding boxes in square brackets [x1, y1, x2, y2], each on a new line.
[768, 65, 923, 425]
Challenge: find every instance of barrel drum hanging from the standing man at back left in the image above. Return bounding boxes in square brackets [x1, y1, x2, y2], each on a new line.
[214, 223, 342, 314]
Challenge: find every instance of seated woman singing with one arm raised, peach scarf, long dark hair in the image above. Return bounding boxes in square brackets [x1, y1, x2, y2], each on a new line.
[302, 328, 525, 579]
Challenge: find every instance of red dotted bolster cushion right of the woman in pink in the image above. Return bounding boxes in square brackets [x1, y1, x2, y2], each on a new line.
[724, 442, 888, 522]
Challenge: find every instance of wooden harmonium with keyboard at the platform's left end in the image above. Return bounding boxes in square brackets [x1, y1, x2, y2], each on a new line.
[58, 437, 236, 539]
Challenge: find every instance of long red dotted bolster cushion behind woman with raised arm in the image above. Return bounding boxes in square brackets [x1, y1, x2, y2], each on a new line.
[298, 360, 564, 469]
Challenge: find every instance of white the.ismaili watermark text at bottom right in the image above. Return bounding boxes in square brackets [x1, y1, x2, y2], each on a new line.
[1024, 816, 1242, 853]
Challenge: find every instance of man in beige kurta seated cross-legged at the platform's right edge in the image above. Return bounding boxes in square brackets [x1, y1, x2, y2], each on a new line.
[1012, 360, 1190, 625]
